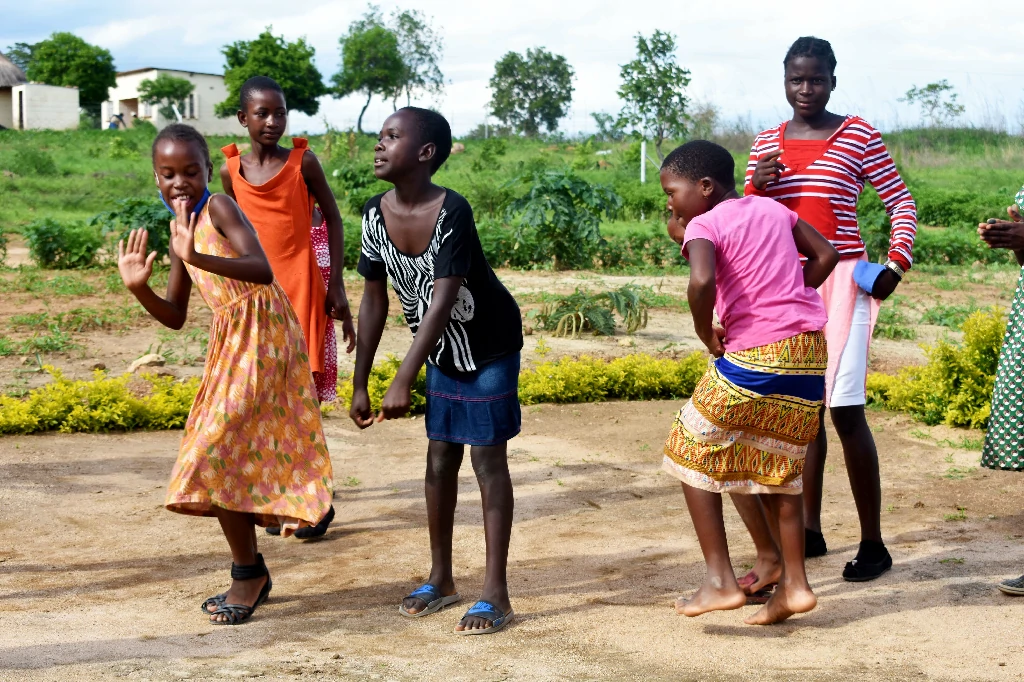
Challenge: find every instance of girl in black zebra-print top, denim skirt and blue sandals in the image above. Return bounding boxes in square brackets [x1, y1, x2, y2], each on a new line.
[348, 106, 522, 635]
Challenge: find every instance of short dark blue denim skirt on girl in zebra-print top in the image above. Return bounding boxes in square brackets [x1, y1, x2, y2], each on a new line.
[425, 353, 522, 445]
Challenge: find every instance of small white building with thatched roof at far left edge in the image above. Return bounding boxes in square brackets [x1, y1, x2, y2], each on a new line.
[0, 54, 79, 130]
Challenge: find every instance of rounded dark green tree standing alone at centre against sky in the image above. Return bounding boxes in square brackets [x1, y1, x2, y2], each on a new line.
[490, 47, 575, 136]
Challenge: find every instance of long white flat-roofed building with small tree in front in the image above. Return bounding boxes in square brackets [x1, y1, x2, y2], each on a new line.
[100, 67, 245, 135]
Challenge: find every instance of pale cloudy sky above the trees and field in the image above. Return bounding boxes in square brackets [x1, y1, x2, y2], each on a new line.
[0, 0, 1024, 133]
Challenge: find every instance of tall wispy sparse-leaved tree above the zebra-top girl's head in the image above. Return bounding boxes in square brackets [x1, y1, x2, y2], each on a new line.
[389, 9, 444, 109]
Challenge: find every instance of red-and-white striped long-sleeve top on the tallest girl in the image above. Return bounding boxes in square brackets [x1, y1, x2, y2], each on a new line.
[743, 116, 918, 269]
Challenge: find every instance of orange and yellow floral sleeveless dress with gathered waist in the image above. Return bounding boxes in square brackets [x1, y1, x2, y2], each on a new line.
[165, 203, 334, 535]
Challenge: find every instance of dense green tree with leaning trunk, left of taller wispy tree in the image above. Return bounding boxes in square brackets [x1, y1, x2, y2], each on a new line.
[331, 13, 406, 134]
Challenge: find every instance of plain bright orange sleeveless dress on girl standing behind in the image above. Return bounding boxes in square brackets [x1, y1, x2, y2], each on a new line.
[220, 137, 332, 372]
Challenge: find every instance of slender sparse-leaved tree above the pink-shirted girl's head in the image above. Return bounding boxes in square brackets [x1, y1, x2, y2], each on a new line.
[618, 30, 690, 166]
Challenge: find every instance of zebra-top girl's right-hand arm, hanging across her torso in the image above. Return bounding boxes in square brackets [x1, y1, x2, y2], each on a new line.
[379, 276, 463, 420]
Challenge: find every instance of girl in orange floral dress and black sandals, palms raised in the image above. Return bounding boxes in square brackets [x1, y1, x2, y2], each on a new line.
[118, 124, 332, 625]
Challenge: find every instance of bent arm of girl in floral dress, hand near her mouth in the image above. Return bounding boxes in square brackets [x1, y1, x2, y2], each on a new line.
[171, 195, 273, 285]
